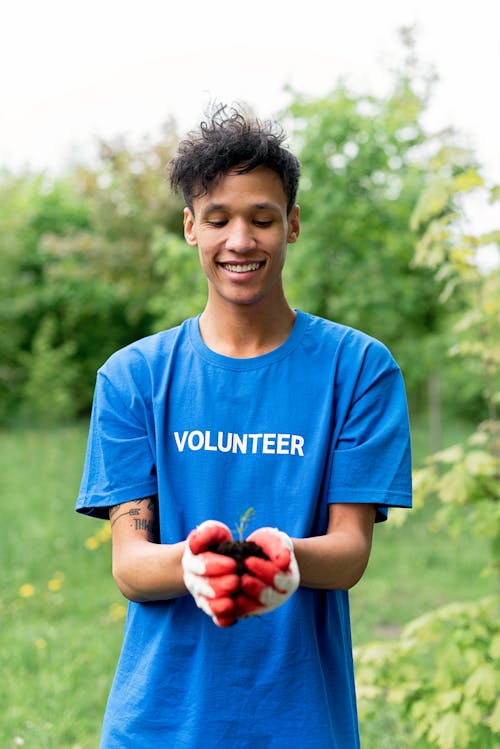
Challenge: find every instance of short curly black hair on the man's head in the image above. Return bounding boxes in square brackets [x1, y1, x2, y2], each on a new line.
[169, 105, 300, 213]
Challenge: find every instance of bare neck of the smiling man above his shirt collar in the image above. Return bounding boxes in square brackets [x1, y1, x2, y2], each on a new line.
[200, 296, 296, 359]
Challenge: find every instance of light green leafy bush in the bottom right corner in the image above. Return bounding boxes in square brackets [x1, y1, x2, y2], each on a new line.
[355, 596, 500, 749]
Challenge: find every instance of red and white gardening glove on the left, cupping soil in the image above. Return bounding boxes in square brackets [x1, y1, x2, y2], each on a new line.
[182, 520, 240, 627]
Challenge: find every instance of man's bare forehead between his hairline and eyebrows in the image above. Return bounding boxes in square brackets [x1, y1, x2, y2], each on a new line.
[193, 166, 287, 211]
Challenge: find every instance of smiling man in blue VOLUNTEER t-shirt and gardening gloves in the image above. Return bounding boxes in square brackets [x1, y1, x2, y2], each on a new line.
[77, 110, 411, 749]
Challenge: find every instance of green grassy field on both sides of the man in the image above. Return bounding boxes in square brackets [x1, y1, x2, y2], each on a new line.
[0, 423, 494, 749]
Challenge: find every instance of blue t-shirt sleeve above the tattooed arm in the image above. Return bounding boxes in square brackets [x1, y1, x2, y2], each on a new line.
[76, 366, 157, 518]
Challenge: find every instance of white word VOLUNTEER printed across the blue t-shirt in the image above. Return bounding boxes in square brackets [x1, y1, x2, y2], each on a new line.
[174, 429, 304, 458]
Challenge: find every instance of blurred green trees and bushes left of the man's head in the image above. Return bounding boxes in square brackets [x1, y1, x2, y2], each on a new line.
[0, 123, 184, 421]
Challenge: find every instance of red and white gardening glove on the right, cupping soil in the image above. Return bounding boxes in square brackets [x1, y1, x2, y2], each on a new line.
[236, 528, 300, 617]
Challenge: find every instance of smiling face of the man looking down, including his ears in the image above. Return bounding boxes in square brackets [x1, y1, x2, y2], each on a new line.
[184, 167, 300, 304]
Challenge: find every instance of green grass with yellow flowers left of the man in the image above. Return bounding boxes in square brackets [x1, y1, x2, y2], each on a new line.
[0, 426, 122, 749]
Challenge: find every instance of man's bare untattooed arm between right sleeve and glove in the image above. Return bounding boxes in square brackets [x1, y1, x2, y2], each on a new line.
[293, 503, 375, 590]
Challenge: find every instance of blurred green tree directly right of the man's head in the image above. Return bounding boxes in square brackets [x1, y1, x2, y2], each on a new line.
[286, 33, 465, 404]
